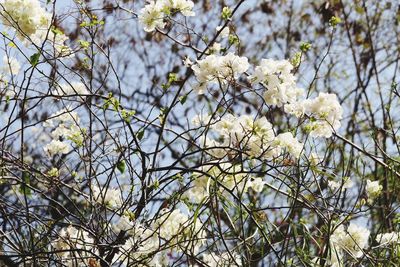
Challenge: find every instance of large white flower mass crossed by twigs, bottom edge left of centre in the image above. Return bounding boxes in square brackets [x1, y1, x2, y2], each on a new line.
[115, 209, 206, 266]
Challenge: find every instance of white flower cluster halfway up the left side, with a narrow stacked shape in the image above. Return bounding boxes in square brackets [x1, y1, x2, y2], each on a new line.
[43, 108, 84, 157]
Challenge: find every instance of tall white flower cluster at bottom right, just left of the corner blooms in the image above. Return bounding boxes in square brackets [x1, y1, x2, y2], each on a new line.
[330, 223, 370, 266]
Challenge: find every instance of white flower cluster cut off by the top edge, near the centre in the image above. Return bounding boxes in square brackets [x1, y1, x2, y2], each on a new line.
[139, 0, 195, 32]
